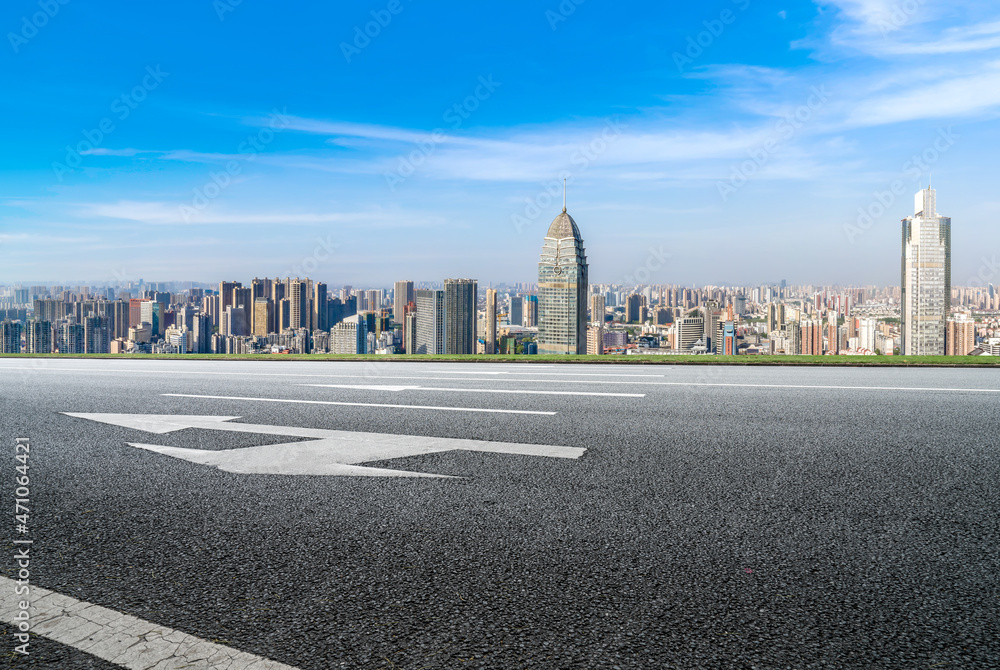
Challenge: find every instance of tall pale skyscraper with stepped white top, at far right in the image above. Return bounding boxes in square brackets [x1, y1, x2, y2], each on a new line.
[899, 186, 951, 356]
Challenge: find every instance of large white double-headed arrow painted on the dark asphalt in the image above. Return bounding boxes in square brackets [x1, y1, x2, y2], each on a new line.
[64, 412, 586, 477]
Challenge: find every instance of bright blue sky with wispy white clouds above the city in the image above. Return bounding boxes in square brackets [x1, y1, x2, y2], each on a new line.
[0, 0, 1000, 286]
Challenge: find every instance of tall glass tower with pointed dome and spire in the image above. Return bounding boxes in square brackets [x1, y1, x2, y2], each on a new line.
[538, 204, 590, 354]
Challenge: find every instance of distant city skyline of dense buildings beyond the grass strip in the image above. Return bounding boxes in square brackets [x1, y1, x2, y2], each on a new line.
[0, 187, 1000, 356]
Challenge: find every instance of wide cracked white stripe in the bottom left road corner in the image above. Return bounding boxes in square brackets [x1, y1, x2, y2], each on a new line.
[0, 577, 296, 670]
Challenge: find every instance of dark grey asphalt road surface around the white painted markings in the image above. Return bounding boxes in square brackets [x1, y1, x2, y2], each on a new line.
[0, 359, 1000, 670]
